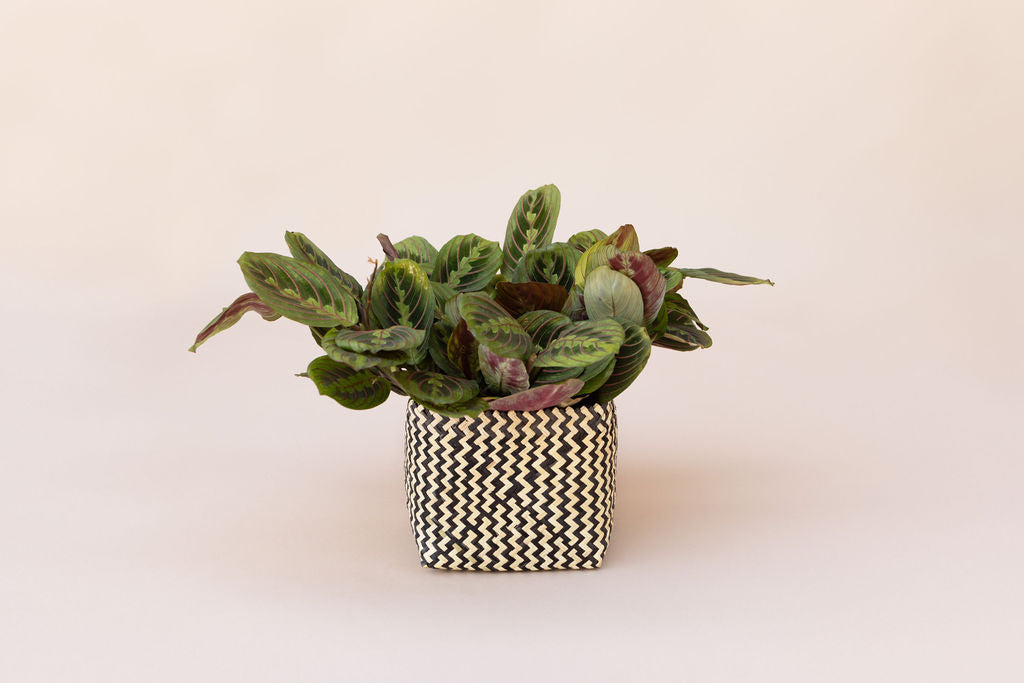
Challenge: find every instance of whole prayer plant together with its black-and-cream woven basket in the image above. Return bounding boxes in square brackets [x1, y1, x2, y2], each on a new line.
[189, 185, 772, 570]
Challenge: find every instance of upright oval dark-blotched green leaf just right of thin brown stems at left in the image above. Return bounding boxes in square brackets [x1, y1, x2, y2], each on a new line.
[370, 259, 436, 331]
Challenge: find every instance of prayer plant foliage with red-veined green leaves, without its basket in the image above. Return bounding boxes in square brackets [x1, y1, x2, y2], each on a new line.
[189, 185, 773, 416]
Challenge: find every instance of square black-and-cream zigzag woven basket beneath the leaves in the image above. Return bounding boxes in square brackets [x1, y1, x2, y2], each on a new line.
[406, 400, 617, 571]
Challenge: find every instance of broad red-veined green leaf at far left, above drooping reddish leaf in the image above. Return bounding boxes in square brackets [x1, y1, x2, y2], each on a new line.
[239, 252, 359, 328]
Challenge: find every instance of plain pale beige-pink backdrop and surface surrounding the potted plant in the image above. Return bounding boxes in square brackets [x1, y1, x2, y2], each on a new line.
[0, 0, 1024, 683]
